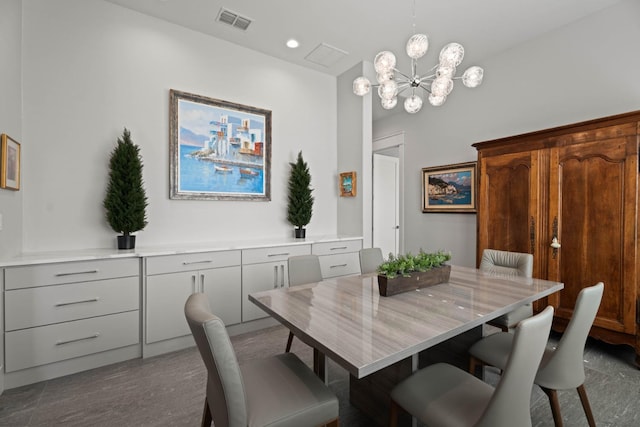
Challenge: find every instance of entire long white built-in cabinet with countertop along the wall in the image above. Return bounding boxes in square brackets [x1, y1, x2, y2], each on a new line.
[0, 238, 362, 393]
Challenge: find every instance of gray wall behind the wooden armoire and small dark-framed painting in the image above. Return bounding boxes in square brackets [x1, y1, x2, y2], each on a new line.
[373, 0, 640, 266]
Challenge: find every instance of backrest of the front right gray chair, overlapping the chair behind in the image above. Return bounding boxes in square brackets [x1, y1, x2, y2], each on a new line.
[477, 306, 553, 427]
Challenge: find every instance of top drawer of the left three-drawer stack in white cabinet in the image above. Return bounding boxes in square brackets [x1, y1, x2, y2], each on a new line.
[5, 258, 140, 289]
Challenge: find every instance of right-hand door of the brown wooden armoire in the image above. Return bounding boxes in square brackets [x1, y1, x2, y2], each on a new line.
[546, 137, 638, 333]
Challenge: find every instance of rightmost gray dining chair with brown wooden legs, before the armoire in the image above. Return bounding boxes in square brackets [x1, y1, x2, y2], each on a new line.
[469, 282, 604, 427]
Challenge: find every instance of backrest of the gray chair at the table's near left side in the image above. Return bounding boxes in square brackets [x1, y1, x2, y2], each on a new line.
[184, 293, 247, 427]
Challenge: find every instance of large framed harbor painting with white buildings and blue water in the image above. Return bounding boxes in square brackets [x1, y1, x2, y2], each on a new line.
[169, 89, 271, 201]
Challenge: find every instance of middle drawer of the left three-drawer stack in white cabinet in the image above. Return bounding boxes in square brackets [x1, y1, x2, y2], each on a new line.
[5, 277, 140, 331]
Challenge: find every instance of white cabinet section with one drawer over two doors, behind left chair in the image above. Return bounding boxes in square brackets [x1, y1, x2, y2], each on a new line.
[145, 250, 242, 344]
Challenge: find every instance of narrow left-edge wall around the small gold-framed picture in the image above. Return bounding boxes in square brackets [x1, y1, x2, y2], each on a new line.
[0, 0, 23, 257]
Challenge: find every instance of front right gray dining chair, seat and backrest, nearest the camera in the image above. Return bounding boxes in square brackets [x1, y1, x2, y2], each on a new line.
[389, 306, 553, 427]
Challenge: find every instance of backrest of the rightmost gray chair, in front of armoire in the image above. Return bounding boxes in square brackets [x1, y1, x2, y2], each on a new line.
[536, 282, 604, 390]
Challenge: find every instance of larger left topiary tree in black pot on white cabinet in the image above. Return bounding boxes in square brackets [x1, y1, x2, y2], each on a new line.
[103, 128, 149, 249]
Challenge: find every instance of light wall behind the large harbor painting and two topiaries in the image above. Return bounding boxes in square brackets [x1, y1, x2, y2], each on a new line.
[18, 0, 338, 251]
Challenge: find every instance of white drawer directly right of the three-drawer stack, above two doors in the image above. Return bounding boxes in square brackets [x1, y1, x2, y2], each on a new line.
[146, 251, 240, 276]
